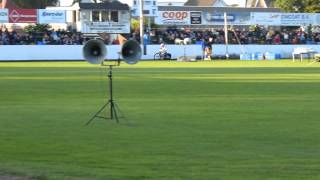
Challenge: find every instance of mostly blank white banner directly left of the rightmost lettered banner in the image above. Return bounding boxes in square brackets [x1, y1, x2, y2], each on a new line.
[251, 12, 281, 26]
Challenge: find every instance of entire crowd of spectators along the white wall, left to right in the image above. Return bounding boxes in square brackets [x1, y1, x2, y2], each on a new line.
[0, 25, 320, 45]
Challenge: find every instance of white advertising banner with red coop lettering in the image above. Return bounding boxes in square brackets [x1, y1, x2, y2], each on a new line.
[155, 11, 191, 25]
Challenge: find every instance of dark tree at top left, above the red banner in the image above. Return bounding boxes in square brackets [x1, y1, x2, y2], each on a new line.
[11, 0, 59, 9]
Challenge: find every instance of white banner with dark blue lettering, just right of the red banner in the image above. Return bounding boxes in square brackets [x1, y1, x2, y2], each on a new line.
[38, 9, 66, 24]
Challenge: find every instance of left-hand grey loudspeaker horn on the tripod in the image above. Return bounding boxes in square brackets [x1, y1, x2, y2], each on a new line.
[82, 39, 107, 64]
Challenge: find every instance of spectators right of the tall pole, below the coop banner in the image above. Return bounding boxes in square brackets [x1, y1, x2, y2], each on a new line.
[149, 25, 320, 44]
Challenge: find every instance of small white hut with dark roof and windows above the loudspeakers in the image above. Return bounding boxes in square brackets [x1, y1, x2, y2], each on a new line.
[46, 0, 130, 34]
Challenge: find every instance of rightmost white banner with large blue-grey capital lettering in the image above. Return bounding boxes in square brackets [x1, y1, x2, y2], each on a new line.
[281, 13, 316, 26]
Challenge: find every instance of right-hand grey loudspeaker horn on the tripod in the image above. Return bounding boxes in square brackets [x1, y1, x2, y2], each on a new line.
[121, 40, 142, 64]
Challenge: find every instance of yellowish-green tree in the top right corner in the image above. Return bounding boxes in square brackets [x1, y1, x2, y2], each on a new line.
[274, 0, 320, 13]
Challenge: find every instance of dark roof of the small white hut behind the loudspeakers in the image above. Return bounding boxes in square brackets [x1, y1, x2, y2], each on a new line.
[79, 1, 129, 10]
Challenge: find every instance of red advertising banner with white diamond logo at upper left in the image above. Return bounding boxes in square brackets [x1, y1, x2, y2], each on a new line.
[9, 9, 37, 23]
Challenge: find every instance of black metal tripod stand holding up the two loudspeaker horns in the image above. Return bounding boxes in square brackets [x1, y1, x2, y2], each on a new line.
[85, 61, 122, 126]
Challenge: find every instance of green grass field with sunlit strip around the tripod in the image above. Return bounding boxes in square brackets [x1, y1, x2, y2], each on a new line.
[0, 61, 320, 180]
